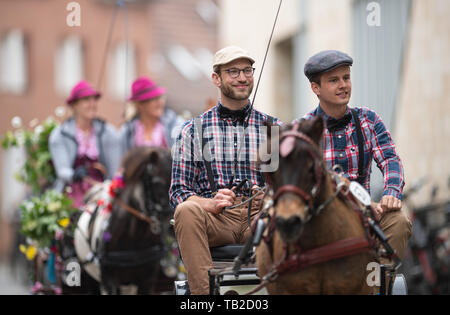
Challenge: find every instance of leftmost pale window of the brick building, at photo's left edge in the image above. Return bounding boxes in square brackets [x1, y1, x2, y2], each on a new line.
[0, 30, 27, 94]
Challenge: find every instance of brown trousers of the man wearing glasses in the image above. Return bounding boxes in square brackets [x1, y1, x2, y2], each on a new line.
[174, 197, 258, 294]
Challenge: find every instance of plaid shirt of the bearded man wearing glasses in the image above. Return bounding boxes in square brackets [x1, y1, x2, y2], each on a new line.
[169, 103, 279, 209]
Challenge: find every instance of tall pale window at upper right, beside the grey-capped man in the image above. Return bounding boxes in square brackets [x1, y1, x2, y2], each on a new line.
[352, 0, 411, 129]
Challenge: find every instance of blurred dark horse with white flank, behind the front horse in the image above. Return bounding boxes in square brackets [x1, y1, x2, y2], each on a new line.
[74, 147, 177, 294]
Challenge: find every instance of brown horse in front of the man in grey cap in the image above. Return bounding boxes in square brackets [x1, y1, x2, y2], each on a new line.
[256, 117, 377, 294]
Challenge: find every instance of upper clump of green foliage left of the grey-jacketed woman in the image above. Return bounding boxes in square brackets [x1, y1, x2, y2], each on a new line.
[2, 118, 58, 195]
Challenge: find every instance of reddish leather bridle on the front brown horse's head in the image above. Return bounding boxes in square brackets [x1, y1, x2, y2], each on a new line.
[272, 122, 325, 220]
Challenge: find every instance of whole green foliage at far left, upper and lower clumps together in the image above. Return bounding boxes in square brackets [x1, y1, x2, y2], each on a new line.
[2, 117, 76, 248]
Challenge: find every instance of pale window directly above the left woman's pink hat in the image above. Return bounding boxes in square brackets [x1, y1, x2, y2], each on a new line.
[55, 37, 84, 96]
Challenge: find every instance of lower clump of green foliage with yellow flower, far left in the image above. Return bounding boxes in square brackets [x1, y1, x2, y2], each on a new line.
[20, 190, 76, 248]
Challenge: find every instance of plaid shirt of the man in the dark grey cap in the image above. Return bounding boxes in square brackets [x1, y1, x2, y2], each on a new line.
[303, 106, 405, 199]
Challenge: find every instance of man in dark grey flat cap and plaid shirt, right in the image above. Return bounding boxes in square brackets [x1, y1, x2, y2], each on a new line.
[303, 50, 411, 292]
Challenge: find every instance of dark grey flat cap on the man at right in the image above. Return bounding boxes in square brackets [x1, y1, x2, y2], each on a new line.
[305, 50, 353, 80]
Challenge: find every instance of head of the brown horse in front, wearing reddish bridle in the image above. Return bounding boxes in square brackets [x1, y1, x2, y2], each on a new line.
[264, 117, 326, 243]
